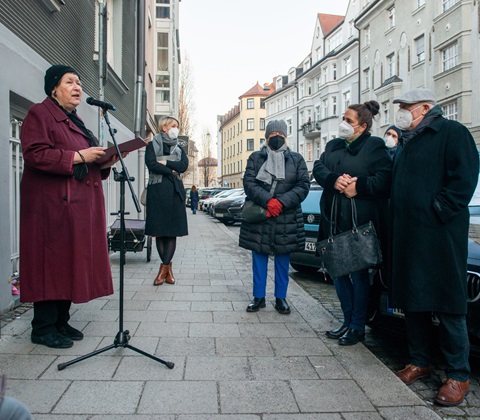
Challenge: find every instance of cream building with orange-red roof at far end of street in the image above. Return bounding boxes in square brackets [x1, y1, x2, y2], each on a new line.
[218, 82, 274, 188]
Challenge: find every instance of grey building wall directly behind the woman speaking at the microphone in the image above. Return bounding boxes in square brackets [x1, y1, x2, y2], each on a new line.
[0, 0, 141, 313]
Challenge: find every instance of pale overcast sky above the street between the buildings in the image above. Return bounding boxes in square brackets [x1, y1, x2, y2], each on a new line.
[179, 0, 348, 153]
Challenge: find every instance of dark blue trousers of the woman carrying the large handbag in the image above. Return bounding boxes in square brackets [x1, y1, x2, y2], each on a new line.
[333, 270, 370, 332]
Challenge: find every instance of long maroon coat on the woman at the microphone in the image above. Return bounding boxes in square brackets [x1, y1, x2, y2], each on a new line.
[20, 98, 113, 303]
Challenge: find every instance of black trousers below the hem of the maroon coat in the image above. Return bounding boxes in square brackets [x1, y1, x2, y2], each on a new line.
[32, 300, 72, 335]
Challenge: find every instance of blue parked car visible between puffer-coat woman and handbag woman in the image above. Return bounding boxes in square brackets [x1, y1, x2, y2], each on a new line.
[290, 181, 323, 273]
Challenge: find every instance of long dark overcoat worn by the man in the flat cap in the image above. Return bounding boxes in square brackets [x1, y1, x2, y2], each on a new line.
[390, 117, 479, 314]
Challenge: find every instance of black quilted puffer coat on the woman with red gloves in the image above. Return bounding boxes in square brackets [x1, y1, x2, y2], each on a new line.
[239, 148, 310, 255]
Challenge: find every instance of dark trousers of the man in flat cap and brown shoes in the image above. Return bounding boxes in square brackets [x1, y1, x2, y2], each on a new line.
[405, 312, 470, 382]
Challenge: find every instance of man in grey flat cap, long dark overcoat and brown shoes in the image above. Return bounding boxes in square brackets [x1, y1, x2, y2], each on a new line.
[389, 89, 479, 406]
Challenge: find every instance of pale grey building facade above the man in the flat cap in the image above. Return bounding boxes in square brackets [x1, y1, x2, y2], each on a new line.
[356, 0, 480, 144]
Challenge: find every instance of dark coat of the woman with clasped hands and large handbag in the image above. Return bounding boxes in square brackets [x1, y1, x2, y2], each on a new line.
[313, 133, 392, 255]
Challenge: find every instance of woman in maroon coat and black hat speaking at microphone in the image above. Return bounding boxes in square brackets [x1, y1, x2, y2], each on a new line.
[20, 64, 122, 348]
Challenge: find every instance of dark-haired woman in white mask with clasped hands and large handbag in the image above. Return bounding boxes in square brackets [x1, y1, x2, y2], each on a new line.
[313, 101, 392, 346]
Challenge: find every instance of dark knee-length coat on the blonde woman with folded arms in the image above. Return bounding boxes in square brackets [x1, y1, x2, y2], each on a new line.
[145, 142, 188, 237]
